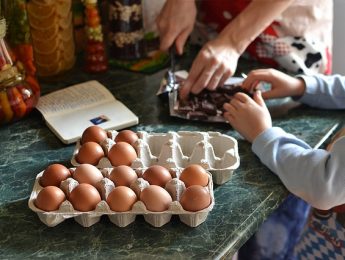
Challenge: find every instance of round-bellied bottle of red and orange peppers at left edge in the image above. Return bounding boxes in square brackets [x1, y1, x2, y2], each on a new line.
[0, 18, 40, 125]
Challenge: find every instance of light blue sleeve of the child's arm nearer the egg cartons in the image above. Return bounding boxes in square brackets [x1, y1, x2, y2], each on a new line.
[252, 127, 345, 209]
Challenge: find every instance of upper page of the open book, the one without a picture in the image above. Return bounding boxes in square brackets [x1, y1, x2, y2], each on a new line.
[36, 80, 115, 118]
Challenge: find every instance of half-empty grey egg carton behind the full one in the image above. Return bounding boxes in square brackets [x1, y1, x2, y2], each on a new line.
[71, 131, 240, 185]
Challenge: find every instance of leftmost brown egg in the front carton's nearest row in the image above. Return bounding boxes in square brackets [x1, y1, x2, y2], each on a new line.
[35, 186, 66, 211]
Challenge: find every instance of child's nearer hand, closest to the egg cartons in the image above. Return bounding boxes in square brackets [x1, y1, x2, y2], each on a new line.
[224, 91, 272, 142]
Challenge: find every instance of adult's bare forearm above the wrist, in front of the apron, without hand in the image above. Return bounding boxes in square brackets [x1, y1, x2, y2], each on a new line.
[220, 0, 294, 54]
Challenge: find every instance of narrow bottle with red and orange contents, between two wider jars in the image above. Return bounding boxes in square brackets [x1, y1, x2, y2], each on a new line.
[84, 0, 108, 73]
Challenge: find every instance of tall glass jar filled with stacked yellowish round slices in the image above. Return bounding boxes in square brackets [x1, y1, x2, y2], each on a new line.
[27, 0, 76, 77]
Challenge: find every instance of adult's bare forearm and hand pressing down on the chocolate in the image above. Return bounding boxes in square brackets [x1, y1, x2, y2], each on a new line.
[180, 0, 294, 99]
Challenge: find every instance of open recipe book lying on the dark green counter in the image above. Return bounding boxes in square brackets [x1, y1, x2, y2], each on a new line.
[36, 80, 139, 144]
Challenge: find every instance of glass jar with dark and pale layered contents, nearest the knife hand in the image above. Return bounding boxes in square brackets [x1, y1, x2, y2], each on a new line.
[109, 0, 145, 60]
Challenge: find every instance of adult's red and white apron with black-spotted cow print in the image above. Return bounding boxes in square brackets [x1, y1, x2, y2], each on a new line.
[196, 0, 332, 74]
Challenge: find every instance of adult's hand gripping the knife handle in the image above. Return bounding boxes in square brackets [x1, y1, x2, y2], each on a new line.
[156, 0, 197, 55]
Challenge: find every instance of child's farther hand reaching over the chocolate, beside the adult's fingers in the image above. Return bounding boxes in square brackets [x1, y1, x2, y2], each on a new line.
[242, 69, 305, 99]
